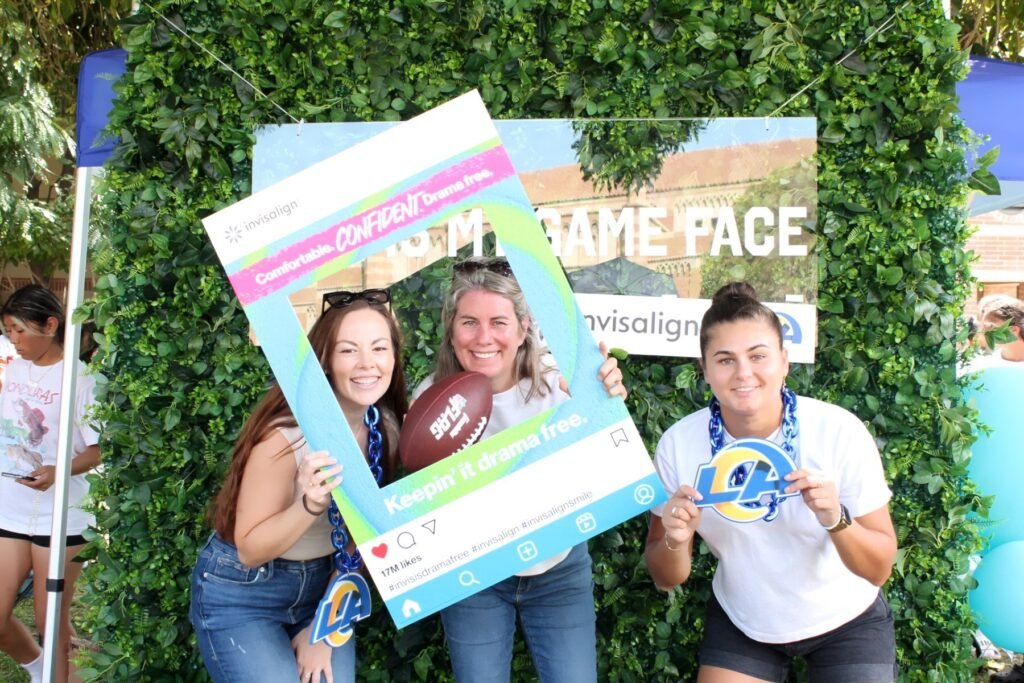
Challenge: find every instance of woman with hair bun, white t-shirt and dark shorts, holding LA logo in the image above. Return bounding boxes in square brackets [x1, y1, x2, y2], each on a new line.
[644, 283, 896, 683]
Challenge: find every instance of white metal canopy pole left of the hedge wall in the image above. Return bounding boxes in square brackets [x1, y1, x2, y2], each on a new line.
[43, 167, 96, 683]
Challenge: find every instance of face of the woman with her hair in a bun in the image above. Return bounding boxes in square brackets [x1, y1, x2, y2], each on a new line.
[701, 319, 790, 438]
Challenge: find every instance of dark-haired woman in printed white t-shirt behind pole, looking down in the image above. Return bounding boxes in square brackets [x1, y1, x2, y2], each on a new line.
[0, 285, 99, 682]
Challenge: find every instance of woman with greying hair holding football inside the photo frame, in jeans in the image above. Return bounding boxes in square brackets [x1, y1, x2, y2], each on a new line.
[415, 258, 626, 683]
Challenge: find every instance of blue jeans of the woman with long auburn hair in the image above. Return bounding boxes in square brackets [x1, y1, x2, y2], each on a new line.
[188, 535, 355, 683]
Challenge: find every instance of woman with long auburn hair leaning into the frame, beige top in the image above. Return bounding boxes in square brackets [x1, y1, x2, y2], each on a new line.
[189, 290, 407, 683]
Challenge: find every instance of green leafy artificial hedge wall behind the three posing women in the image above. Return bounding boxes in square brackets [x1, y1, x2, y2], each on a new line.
[84, 0, 982, 681]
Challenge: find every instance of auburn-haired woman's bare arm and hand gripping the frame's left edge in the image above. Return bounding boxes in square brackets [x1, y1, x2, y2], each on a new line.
[234, 430, 341, 566]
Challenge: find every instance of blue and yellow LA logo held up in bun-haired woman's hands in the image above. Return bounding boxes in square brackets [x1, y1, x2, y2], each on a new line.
[693, 438, 797, 522]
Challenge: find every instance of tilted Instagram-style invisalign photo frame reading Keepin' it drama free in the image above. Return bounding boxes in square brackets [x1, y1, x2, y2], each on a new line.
[203, 92, 666, 627]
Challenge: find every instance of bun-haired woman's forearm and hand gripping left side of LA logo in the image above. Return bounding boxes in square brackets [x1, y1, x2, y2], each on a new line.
[643, 485, 700, 591]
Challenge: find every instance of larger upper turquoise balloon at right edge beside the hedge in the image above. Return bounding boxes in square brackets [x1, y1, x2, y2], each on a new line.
[967, 364, 1024, 548]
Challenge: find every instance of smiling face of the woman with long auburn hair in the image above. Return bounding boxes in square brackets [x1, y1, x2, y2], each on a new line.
[330, 308, 395, 413]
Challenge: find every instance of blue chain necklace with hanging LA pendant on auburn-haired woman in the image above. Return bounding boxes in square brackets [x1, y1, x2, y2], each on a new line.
[309, 405, 384, 647]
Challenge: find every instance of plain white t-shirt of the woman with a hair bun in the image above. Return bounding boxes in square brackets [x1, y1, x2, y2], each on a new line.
[651, 396, 892, 643]
